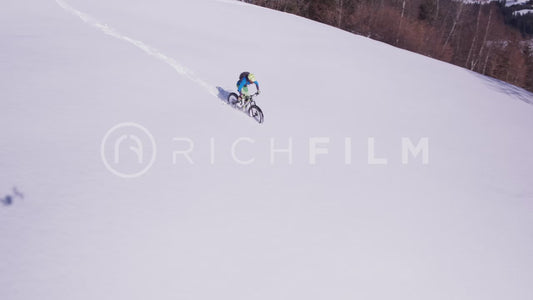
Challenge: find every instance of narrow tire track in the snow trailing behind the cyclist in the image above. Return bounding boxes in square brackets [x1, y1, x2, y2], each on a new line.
[56, 0, 218, 97]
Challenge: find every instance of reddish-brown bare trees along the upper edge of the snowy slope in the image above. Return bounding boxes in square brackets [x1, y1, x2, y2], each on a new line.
[248, 0, 533, 91]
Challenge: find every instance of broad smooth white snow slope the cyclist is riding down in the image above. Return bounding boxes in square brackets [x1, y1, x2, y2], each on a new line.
[0, 0, 533, 300]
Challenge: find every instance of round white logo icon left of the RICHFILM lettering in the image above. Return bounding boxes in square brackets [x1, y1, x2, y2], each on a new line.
[100, 122, 157, 178]
